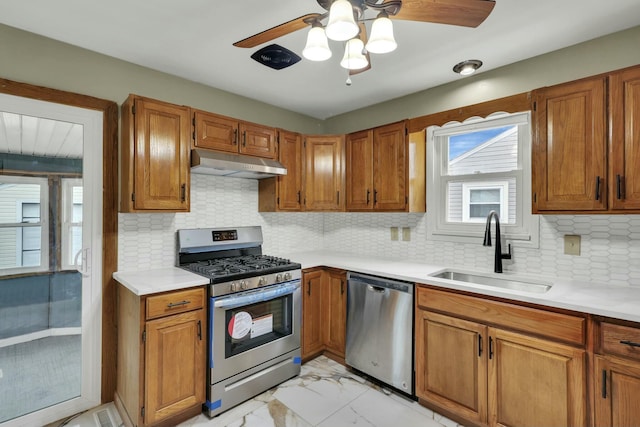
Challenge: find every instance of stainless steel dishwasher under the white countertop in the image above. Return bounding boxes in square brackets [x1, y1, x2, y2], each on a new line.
[345, 272, 414, 396]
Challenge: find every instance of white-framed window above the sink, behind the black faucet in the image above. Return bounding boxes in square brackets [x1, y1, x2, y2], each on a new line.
[427, 113, 538, 246]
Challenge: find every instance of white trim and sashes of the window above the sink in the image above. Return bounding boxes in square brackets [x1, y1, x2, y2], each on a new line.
[426, 111, 540, 248]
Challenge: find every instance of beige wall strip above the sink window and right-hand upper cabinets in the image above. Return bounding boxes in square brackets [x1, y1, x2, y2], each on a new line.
[325, 26, 640, 133]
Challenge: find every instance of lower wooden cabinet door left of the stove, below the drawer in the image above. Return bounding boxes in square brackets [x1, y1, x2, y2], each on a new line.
[145, 309, 206, 424]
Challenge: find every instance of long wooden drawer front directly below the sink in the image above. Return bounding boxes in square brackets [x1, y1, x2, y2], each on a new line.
[417, 286, 586, 346]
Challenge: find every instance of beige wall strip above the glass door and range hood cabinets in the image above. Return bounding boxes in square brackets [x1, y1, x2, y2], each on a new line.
[0, 24, 323, 133]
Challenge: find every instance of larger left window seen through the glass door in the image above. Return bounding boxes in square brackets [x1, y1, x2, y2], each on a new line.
[0, 175, 49, 275]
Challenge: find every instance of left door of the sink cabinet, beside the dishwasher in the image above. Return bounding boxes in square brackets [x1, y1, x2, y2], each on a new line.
[416, 310, 487, 423]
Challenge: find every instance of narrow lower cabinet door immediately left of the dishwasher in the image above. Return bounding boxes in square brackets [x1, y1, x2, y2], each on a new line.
[322, 269, 347, 358]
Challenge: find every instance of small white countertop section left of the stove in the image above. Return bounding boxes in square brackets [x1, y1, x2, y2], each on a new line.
[113, 267, 209, 295]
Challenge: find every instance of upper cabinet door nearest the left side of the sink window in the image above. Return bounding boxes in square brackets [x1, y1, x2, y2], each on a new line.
[373, 122, 408, 211]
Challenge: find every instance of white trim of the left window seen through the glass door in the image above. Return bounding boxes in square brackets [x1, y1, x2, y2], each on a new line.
[0, 175, 49, 276]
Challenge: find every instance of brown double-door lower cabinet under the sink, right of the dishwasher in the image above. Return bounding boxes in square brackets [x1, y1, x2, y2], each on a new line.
[416, 286, 588, 427]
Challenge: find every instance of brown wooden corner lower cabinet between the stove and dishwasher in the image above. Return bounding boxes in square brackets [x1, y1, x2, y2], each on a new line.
[302, 267, 347, 360]
